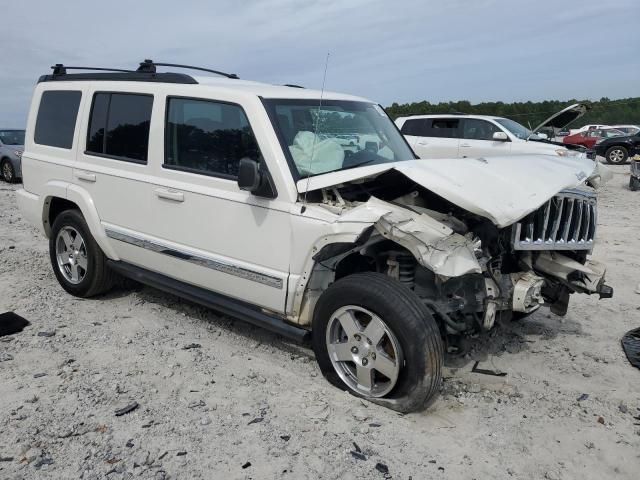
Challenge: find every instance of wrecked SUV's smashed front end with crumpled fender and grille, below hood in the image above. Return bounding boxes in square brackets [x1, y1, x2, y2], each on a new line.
[297, 159, 613, 335]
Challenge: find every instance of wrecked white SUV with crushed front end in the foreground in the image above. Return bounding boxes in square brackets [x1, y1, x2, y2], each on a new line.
[18, 61, 612, 412]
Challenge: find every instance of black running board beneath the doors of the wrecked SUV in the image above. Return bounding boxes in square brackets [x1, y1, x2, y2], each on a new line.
[107, 260, 310, 344]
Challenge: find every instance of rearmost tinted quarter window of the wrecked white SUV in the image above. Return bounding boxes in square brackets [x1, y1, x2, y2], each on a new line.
[34, 90, 82, 148]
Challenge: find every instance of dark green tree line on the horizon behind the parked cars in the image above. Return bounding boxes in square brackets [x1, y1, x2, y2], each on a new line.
[385, 97, 640, 128]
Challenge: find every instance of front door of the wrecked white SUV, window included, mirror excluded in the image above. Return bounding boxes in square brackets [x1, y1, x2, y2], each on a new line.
[139, 97, 291, 312]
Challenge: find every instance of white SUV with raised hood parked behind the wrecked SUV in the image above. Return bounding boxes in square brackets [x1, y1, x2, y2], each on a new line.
[396, 104, 595, 158]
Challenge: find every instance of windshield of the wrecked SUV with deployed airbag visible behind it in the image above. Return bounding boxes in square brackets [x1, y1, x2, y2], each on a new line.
[264, 99, 416, 179]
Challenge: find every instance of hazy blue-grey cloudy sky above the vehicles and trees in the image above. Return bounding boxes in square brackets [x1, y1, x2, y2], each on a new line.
[0, 0, 640, 127]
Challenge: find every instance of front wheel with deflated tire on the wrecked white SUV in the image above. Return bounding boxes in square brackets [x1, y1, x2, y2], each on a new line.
[312, 273, 444, 413]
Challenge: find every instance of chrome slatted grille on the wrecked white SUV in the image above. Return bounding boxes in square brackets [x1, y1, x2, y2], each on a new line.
[512, 190, 597, 250]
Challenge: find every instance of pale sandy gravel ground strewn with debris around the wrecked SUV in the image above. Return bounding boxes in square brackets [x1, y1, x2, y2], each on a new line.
[0, 166, 640, 480]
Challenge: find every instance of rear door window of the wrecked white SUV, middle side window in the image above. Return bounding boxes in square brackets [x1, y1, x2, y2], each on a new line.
[87, 93, 153, 163]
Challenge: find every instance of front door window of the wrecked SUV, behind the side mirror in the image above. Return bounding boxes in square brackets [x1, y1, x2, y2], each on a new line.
[164, 98, 260, 178]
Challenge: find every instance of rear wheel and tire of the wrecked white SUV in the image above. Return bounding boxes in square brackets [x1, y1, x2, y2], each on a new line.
[49, 210, 116, 298]
